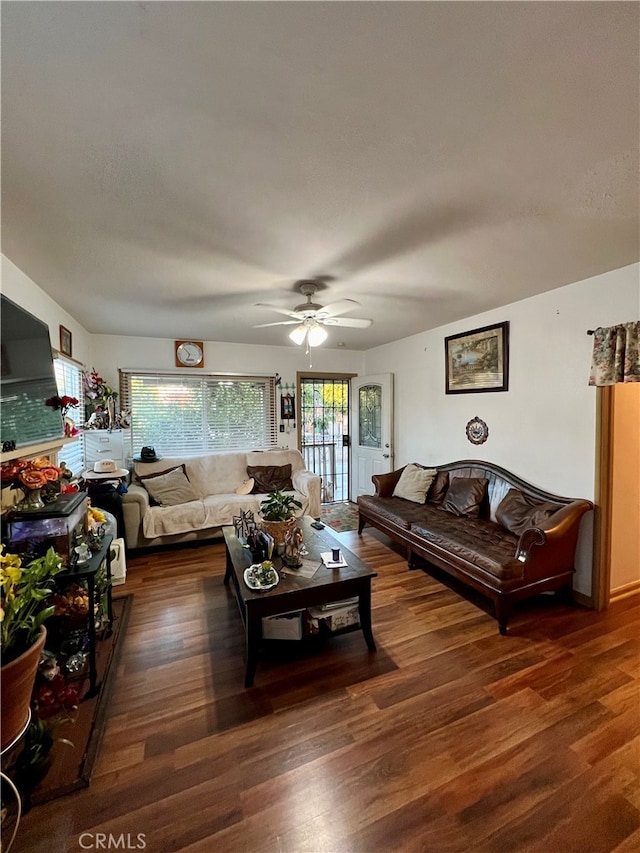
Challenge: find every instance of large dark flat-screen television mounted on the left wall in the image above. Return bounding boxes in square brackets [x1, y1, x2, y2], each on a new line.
[0, 295, 64, 448]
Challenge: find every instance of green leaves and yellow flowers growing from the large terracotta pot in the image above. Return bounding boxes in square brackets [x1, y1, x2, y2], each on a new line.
[0, 545, 64, 664]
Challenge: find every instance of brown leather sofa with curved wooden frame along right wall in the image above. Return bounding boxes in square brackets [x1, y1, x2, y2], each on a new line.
[358, 459, 593, 634]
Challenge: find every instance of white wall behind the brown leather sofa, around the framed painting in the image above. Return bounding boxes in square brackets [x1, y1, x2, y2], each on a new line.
[364, 264, 640, 595]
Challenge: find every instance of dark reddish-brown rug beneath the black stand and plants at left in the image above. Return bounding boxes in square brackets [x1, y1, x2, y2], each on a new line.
[14, 595, 133, 808]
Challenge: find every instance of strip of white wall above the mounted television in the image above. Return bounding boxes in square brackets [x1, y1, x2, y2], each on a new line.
[0, 255, 91, 363]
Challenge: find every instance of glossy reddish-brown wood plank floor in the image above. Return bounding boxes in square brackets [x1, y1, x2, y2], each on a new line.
[13, 530, 640, 853]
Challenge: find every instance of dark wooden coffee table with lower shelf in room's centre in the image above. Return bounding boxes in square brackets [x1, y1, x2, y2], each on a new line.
[222, 516, 377, 687]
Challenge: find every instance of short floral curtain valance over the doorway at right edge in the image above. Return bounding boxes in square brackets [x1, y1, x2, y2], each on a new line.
[589, 321, 640, 385]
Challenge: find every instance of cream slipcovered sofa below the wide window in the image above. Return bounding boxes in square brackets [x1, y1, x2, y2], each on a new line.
[122, 450, 320, 548]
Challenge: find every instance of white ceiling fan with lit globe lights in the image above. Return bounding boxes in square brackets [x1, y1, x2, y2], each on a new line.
[253, 280, 373, 352]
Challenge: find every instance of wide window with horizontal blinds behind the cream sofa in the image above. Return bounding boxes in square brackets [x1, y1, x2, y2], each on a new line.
[120, 371, 276, 456]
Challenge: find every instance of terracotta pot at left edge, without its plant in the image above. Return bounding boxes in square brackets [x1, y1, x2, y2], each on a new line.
[0, 625, 47, 749]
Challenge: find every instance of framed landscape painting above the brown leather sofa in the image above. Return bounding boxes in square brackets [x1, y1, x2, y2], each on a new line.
[444, 322, 509, 394]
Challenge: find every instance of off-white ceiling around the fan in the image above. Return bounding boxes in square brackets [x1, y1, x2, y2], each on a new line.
[2, 0, 640, 349]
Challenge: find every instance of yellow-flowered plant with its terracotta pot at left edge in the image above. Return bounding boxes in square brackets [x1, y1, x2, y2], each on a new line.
[0, 546, 63, 749]
